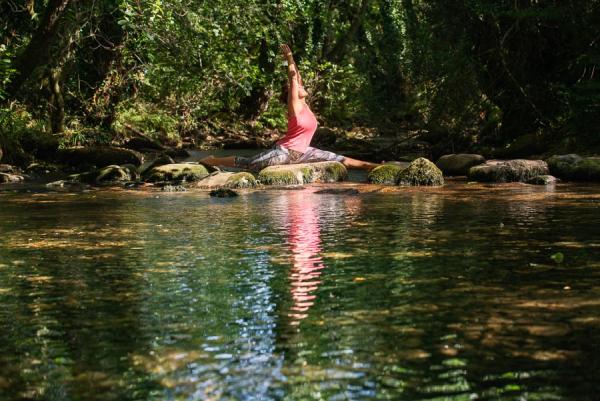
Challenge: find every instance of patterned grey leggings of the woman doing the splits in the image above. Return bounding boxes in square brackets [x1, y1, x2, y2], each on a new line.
[235, 145, 344, 171]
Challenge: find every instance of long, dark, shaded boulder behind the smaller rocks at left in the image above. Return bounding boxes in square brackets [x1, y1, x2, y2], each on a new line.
[57, 146, 144, 167]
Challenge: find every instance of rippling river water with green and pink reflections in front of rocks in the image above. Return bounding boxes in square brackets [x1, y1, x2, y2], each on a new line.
[0, 181, 600, 400]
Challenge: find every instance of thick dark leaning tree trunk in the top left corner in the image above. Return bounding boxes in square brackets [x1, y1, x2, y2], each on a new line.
[6, 0, 77, 97]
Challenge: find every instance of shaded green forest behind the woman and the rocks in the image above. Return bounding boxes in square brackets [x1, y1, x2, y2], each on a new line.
[0, 0, 600, 162]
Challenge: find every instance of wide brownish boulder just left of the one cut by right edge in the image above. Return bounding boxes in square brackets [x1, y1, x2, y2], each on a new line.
[469, 159, 548, 182]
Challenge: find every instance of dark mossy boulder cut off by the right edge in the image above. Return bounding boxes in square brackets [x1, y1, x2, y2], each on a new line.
[546, 154, 600, 181]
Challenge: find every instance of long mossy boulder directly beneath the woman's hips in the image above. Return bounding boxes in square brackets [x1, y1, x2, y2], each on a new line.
[258, 162, 348, 185]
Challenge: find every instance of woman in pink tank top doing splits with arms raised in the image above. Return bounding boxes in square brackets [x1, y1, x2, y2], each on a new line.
[200, 45, 378, 171]
